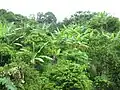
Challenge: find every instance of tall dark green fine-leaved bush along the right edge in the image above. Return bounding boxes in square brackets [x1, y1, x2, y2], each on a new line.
[86, 33, 120, 90]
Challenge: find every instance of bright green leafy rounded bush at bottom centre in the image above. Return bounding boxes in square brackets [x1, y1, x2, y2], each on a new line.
[41, 60, 92, 90]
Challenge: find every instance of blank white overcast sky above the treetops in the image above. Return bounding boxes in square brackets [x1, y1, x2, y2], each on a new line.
[0, 0, 120, 20]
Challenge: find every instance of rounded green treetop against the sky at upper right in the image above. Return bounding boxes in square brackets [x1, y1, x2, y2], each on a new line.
[88, 13, 120, 32]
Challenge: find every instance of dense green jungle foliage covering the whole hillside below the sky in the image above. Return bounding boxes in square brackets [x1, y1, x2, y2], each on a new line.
[0, 9, 120, 90]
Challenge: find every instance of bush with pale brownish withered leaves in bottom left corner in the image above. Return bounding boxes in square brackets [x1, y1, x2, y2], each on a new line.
[0, 61, 40, 90]
